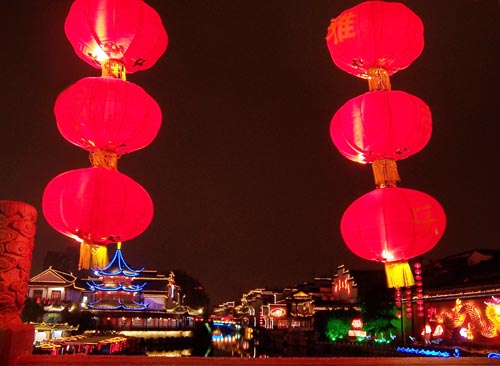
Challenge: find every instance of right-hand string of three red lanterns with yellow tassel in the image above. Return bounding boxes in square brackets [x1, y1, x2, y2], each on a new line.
[326, 1, 446, 316]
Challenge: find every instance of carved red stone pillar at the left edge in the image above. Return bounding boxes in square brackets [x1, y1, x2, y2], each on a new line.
[0, 200, 37, 365]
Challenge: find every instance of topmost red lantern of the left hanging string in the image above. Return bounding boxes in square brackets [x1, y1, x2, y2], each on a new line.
[64, 0, 168, 73]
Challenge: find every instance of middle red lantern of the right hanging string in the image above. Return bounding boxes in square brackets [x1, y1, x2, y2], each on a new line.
[330, 91, 432, 163]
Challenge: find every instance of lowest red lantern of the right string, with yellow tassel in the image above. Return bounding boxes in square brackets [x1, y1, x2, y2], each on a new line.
[340, 187, 446, 288]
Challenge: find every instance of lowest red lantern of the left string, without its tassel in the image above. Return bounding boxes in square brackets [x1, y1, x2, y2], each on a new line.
[42, 167, 153, 245]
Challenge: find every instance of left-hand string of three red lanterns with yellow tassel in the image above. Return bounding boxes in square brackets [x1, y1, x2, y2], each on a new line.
[42, 0, 168, 268]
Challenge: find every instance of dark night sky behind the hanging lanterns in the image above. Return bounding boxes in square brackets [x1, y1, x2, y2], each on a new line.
[0, 0, 500, 303]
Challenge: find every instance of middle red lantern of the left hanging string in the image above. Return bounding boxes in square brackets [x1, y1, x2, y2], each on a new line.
[54, 77, 162, 155]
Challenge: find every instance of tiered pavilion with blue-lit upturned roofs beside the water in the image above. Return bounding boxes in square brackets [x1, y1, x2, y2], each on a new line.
[83, 246, 203, 333]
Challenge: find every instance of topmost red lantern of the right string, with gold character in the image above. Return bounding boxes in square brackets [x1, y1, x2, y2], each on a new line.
[326, 1, 424, 79]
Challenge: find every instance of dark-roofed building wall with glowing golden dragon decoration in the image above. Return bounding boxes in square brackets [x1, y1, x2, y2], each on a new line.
[405, 250, 500, 346]
